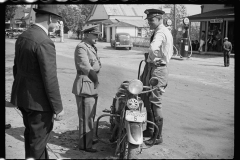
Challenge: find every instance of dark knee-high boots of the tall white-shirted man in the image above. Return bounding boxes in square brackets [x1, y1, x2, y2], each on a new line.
[145, 116, 163, 145]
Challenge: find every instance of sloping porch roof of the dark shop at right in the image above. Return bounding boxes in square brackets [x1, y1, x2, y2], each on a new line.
[188, 8, 234, 21]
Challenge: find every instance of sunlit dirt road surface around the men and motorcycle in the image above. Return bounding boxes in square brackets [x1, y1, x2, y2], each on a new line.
[5, 39, 234, 159]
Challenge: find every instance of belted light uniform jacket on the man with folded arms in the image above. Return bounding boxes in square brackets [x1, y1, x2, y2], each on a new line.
[72, 40, 101, 96]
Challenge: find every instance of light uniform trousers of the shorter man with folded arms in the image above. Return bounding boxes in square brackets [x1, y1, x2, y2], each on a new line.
[75, 95, 97, 149]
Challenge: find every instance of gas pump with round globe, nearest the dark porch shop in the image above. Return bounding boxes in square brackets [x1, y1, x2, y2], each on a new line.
[180, 18, 192, 58]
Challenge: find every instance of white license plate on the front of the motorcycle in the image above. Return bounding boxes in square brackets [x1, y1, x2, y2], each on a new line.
[125, 110, 146, 122]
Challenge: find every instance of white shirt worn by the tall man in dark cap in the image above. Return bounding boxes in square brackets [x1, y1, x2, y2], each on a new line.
[147, 24, 173, 64]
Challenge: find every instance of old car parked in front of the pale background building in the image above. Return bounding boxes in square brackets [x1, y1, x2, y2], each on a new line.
[110, 33, 133, 50]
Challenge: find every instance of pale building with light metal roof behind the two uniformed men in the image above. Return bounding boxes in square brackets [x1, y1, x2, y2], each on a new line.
[83, 4, 167, 42]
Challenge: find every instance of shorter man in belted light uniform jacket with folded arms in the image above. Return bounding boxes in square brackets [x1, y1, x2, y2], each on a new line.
[72, 27, 101, 152]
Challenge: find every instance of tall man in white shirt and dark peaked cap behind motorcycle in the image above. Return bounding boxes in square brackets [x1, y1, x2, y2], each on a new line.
[141, 9, 173, 145]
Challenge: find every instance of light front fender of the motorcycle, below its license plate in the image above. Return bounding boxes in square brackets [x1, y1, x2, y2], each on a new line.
[125, 121, 143, 144]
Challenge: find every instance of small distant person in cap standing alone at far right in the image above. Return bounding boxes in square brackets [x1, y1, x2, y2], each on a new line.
[223, 37, 232, 67]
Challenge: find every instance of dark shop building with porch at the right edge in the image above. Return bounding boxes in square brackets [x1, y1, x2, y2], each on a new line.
[188, 4, 235, 52]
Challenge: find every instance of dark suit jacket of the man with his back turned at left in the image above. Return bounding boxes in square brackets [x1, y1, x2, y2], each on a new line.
[11, 25, 63, 114]
